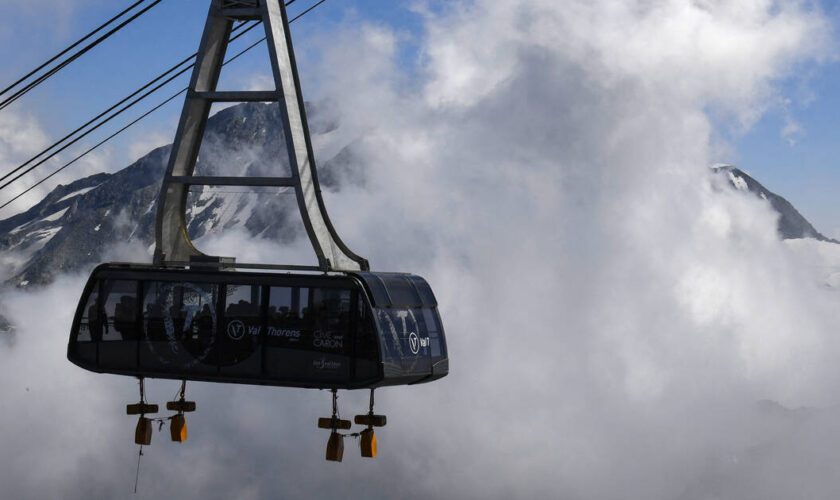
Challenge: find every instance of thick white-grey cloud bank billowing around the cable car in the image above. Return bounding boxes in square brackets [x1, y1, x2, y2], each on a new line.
[0, 0, 840, 499]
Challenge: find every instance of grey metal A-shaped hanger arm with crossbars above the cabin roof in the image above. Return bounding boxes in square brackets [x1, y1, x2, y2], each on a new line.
[154, 0, 369, 271]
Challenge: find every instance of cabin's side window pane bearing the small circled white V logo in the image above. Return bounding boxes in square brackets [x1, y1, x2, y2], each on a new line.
[218, 285, 262, 371]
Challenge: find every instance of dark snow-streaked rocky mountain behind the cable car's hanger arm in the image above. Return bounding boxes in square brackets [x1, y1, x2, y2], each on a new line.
[0, 103, 363, 287]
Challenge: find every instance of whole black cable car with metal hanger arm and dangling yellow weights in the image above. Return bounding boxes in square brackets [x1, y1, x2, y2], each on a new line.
[67, 0, 449, 461]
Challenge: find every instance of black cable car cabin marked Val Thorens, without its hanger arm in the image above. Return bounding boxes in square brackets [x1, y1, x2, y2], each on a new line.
[67, 264, 449, 389]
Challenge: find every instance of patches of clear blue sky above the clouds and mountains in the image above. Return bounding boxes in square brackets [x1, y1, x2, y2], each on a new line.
[0, 0, 840, 237]
